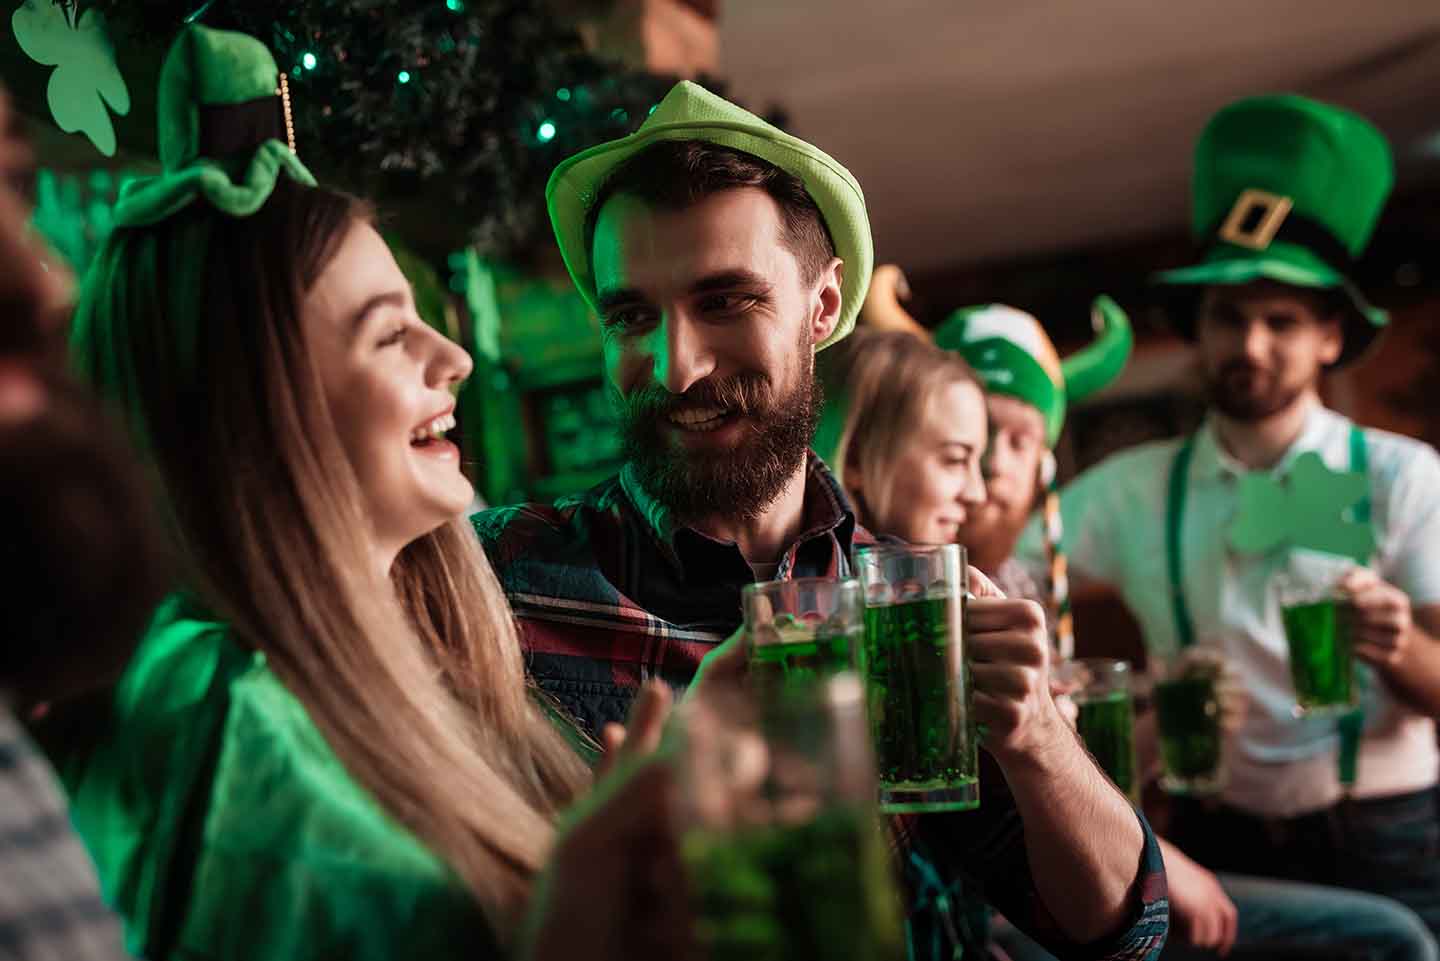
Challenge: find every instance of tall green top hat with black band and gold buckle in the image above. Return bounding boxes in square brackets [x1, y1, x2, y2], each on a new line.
[1152, 95, 1395, 366]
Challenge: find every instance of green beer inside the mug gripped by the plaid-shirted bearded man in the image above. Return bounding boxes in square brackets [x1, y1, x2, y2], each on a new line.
[864, 598, 979, 813]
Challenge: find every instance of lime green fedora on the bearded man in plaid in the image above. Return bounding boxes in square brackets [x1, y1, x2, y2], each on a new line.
[544, 81, 874, 350]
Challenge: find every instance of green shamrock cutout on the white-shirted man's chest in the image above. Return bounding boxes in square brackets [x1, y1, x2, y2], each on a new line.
[1228, 451, 1375, 563]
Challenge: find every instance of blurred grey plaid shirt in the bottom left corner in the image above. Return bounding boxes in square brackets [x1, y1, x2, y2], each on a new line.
[0, 703, 130, 961]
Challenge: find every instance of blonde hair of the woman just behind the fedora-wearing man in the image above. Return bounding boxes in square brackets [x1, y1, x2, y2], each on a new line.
[816, 327, 979, 532]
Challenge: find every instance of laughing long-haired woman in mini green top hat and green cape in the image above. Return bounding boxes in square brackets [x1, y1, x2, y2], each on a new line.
[50, 27, 696, 961]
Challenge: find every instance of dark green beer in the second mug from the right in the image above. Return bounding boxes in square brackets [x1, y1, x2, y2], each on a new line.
[1155, 674, 1223, 794]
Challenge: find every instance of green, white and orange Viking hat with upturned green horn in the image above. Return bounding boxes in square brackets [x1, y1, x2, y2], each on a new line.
[935, 297, 1135, 448]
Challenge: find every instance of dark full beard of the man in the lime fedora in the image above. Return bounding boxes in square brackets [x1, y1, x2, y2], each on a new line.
[618, 365, 822, 523]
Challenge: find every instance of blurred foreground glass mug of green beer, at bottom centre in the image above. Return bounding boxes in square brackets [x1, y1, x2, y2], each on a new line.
[672, 671, 906, 961]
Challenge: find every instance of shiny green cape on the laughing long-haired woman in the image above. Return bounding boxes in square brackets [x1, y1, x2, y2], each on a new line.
[53, 598, 501, 961]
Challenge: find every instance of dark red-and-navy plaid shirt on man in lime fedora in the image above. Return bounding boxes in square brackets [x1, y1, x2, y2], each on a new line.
[472, 455, 1169, 961]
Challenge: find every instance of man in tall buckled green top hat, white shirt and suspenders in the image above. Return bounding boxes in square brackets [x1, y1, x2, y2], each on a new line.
[1036, 97, 1440, 929]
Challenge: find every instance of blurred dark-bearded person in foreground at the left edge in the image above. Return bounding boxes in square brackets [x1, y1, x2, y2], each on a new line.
[0, 91, 164, 961]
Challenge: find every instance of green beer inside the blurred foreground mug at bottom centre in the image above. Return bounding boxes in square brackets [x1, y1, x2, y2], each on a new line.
[681, 807, 906, 961]
